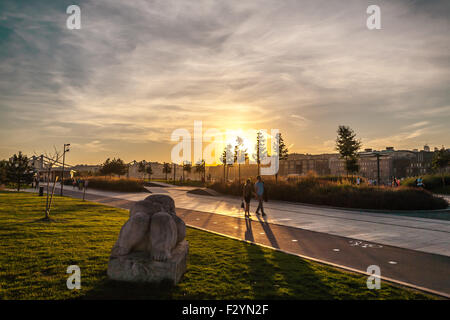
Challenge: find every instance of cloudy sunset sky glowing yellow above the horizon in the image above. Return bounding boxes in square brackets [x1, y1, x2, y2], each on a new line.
[0, 0, 450, 164]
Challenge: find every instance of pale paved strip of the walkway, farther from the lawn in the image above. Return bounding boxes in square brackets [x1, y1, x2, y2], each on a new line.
[52, 187, 450, 256]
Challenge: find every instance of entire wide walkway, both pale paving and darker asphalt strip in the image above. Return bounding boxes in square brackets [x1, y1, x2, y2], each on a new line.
[23, 187, 450, 298]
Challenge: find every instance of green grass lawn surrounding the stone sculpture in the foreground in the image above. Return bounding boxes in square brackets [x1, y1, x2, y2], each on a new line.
[0, 192, 432, 299]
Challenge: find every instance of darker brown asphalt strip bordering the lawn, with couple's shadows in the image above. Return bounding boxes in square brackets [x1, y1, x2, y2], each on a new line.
[56, 189, 450, 298]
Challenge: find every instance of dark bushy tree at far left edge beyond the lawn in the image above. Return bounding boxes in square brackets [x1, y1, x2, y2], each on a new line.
[6, 151, 35, 192]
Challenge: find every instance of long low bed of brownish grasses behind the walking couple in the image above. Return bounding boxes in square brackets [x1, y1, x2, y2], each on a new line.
[209, 178, 448, 210]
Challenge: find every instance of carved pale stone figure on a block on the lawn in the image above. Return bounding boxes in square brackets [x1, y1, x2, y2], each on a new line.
[108, 194, 189, 283]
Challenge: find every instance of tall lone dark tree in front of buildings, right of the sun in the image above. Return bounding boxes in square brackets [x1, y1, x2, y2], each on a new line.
[336, 126, 362, 178]
